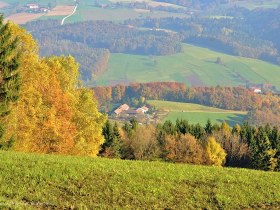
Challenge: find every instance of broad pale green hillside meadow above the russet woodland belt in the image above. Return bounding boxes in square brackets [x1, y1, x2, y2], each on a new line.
[96, 44, 280, 89]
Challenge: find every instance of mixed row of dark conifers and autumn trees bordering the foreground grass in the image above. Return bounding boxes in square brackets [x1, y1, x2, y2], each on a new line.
[99, 120, 280, 171]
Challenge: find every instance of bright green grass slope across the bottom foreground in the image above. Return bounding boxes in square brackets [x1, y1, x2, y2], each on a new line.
[0, 151, 280, 209]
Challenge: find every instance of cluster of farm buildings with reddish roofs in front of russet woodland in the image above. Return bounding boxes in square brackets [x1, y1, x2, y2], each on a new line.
[113, 104, 149, 117]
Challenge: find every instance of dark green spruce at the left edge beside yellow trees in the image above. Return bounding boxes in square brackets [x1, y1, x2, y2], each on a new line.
[0, 15, 20, 141]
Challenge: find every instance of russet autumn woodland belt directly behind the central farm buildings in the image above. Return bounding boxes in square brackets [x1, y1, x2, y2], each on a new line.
[93, 82, 280, 126]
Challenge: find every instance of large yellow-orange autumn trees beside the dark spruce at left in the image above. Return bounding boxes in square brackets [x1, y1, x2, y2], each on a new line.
[0, 24, 106, 156]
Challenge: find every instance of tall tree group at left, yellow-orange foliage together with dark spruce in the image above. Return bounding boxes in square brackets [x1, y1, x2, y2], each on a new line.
[0, 16, 105, 156]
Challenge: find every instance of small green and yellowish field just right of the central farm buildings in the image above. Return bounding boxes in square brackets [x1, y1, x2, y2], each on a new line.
[148, 100, 247, 126]
